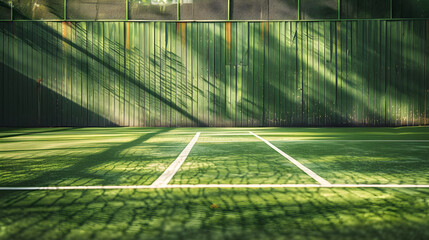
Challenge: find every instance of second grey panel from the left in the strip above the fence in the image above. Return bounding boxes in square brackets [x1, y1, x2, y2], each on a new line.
[67, 0, 127, 20]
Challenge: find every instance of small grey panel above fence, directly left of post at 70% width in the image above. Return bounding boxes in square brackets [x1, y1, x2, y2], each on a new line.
[268, 0, 298, 20]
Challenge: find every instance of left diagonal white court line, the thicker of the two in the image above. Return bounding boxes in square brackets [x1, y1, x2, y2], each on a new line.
[152, 132, 200, 186]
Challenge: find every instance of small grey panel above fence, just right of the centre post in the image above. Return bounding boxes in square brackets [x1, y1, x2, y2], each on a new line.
[231, 0, 268, 20]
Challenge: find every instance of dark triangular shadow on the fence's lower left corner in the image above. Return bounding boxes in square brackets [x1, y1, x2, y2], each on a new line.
[0, 63, 117, 127]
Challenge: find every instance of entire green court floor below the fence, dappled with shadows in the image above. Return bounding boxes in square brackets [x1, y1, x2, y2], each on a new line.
[0, 127, 429, 240]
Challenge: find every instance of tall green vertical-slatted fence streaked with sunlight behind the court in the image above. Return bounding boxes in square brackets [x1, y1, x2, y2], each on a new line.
[0, 20, 429, 126]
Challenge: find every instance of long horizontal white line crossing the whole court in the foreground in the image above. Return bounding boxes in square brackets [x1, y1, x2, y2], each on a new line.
[0, 184, 429, 191]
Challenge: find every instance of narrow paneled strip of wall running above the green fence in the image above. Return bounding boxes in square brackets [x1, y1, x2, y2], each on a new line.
[0, 0, 429, 21]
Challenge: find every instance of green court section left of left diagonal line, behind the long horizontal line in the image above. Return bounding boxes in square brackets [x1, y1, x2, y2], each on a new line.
[0, 128, 194, 186]
